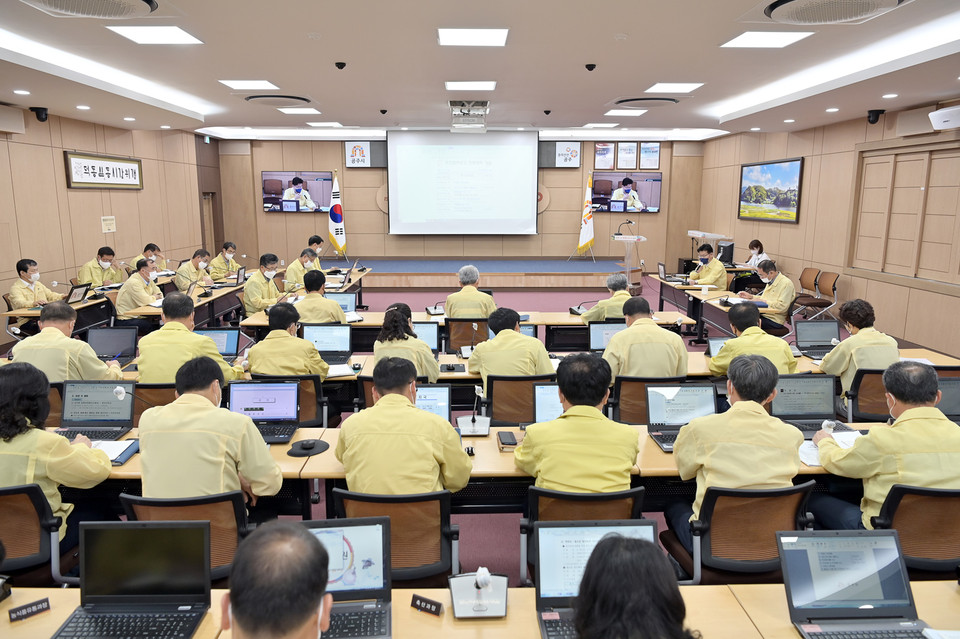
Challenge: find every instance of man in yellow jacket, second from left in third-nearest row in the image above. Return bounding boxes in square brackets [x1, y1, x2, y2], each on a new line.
[137, 293, 243, 384]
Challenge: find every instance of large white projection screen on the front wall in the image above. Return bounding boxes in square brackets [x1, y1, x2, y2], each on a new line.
[387, 131, 538, 235]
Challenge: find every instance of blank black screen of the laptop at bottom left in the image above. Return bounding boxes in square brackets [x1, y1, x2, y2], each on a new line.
[80, 521, 210, 605]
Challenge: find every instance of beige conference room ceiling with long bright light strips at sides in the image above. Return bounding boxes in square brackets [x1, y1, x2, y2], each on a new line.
[0, 0, 960, 139]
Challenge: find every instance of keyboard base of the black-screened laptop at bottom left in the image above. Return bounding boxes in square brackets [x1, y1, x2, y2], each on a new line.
[55, 611, 203, 639]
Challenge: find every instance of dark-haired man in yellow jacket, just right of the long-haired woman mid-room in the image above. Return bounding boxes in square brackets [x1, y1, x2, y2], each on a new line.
[467, 308, 553, 394]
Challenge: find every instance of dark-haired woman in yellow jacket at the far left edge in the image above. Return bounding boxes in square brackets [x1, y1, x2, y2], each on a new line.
[0, 364, 113, 554]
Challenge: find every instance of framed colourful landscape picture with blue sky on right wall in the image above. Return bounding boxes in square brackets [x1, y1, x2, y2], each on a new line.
[737, 158, 803, 224]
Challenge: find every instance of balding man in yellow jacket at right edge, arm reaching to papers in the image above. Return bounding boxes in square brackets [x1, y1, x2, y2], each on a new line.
[807, 362, 960, 530]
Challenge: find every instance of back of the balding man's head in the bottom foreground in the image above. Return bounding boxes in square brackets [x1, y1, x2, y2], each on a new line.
[230, 520, 329, 637]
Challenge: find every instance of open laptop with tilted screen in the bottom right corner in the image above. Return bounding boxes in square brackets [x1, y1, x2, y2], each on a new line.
[777, 530, 927, 639]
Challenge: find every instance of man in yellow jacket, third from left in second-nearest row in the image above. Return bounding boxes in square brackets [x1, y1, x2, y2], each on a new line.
[336, 357, 473, 495]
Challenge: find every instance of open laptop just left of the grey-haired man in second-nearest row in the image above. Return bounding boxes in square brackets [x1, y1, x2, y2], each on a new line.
[647, 383, 717, 453]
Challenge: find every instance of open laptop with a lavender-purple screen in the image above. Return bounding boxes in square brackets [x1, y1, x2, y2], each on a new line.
[227, 380, 300, 444]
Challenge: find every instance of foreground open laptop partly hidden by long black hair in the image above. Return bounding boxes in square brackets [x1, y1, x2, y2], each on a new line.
[533, 519, 657, 639]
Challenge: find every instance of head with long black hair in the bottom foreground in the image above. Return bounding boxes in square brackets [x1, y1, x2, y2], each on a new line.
[574, 535, 700, 639]
